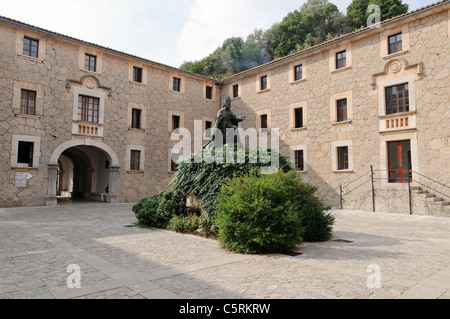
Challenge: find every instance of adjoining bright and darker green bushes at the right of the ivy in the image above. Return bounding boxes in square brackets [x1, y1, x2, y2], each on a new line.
[217, 171, 334, 253]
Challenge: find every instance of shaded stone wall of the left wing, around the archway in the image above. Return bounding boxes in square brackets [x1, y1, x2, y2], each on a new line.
[0, 21, 219, 207]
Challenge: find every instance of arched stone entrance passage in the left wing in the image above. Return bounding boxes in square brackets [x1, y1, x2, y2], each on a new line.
[46, 139, 120, 206]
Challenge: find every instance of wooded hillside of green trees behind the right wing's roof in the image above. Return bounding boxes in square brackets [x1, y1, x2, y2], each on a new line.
[180, 0, 408, 79]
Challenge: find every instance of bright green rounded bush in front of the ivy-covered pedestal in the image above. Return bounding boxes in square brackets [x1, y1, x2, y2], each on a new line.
[217, 172, 304, 253]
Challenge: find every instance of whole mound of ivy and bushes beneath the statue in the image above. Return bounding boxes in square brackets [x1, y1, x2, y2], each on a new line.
[133, 149, 334, 253]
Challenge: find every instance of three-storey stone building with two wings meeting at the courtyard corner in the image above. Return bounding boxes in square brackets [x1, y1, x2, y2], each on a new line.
[0, 0, 450, 215]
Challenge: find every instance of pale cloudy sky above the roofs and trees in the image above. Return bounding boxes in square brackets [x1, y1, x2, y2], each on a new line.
[0, 0, 438, 67]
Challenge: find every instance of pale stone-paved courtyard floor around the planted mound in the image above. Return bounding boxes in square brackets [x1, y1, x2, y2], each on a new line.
[0, 203, 450, 299]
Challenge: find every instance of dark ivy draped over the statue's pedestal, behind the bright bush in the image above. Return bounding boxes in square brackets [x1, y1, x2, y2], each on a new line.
[171, 148, 292, 232]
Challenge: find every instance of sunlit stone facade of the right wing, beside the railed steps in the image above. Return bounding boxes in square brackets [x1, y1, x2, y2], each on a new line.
[222, 2, 450, 214]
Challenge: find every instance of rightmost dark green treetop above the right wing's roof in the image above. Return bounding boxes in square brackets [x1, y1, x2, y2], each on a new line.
[347, 0, 409, 29]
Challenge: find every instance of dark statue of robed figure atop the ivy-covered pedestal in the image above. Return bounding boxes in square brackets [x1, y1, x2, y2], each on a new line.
[203, 97, 245, 148]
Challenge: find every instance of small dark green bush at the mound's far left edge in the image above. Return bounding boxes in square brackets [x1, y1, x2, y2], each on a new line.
[133, 191, 186, 228]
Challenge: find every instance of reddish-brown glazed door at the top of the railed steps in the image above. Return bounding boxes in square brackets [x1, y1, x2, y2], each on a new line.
[388, 141, 412, 183]
